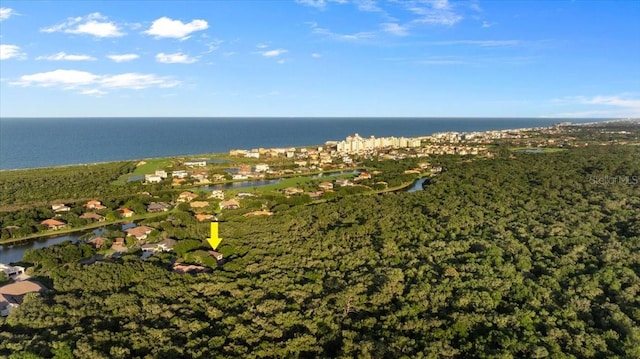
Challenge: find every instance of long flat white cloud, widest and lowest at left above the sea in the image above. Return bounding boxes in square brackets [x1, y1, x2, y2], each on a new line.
[10, 70, 180, 95]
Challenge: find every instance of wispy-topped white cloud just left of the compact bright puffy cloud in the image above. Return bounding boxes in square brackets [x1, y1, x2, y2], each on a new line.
[41, 12, 125, 38]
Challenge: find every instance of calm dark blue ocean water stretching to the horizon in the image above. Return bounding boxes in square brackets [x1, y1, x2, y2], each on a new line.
[0, 118, 594, 170]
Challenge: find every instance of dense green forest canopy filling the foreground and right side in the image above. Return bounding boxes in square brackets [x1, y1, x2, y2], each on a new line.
[0, 146, 640, 358]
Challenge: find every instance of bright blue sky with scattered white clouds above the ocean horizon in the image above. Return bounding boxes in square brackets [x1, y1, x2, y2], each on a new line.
[0, 0, 640, 117]
